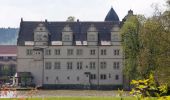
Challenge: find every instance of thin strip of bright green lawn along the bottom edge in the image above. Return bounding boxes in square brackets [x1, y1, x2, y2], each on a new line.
[0, 96, 170, 100]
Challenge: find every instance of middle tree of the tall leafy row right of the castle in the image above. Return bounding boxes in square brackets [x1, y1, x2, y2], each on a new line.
[138, 19, 162, 78]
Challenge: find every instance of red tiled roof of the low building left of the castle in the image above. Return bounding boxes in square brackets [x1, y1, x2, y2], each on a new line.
[0, 45, 17, 55]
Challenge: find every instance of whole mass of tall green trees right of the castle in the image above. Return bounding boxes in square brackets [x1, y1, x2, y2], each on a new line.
[121, 0, 170, 87]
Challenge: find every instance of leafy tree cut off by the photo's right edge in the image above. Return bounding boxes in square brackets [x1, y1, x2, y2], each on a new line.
[155, 8, 170, 87]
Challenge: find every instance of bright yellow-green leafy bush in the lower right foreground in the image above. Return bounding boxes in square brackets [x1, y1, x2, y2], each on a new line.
[130, 74, 167, 97]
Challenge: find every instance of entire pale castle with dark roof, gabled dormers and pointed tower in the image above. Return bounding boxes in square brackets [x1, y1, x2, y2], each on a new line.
[15, 8, 123, 89]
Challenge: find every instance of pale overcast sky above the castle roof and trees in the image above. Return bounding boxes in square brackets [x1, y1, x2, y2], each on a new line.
[0, 0, 166, 27]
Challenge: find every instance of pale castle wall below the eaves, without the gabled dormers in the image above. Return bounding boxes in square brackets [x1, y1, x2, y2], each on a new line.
[18, 46, 123, 85]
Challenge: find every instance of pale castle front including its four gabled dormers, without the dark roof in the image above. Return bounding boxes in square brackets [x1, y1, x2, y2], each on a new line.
[17, 18, 123, 89]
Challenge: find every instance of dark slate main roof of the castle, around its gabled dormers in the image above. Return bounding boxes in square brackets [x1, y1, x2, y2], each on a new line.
[17, 21, 119, 45]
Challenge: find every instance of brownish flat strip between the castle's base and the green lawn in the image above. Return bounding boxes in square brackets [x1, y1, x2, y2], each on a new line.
[17, 90, 129, 97]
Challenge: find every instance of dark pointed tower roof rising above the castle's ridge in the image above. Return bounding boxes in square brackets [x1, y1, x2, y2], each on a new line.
[105, 8, 119, 21]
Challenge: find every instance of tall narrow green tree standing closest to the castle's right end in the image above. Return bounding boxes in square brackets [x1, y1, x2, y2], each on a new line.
[121, 16, 140, 80]
